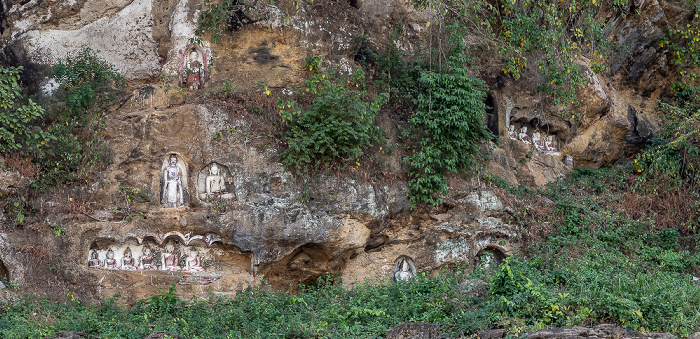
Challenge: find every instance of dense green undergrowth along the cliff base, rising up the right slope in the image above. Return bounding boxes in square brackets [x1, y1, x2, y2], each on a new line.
[0, 157, 700, 338]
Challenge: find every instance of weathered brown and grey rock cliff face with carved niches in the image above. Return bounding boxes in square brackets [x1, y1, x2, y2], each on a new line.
[0, 0, 683, 301]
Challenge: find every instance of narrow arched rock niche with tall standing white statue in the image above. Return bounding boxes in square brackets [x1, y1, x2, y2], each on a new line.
[160, 153, 189, 208]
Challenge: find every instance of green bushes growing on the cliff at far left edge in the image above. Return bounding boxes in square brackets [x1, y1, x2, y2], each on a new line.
[0, 49, 124, 228]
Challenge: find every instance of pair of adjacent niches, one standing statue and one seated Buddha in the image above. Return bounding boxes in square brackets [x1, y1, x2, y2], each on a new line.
[160, 153, 236, 208]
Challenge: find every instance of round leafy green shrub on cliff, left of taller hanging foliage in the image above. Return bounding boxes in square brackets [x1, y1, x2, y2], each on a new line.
[278, 69, 387, 177]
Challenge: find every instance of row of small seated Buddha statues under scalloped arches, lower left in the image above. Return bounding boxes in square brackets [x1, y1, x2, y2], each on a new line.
[88, 247, 204, 272]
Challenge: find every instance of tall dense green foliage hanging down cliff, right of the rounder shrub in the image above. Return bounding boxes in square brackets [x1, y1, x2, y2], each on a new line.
[406, 63, 490, 207]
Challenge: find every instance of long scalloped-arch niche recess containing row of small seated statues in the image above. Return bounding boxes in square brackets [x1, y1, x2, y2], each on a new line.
[87, 232, 250, 274]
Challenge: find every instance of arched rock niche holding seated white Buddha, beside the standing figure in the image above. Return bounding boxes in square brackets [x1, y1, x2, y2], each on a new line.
[197, 162, 236, 201]
